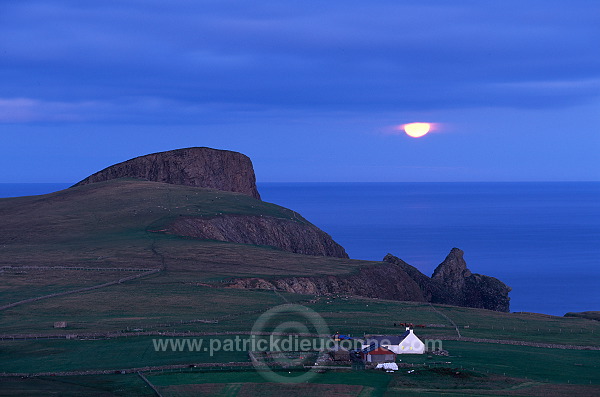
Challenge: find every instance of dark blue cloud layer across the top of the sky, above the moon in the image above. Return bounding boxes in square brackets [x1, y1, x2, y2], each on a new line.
[0, 0, 600, 121]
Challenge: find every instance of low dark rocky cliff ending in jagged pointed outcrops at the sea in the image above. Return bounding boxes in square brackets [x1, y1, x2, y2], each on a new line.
[230, 248, 510, 312]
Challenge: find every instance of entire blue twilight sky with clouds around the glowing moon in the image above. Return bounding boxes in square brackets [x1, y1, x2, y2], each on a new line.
[0, 0, 600, 183]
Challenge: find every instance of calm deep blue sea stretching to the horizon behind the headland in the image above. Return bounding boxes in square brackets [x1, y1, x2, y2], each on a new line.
[0, 182, 600, 316]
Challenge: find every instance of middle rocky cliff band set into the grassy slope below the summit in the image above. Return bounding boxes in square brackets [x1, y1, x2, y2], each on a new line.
[166, 215, 348, 258]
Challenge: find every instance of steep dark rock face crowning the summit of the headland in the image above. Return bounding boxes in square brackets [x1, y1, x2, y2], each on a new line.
[75, 147, 260, 200]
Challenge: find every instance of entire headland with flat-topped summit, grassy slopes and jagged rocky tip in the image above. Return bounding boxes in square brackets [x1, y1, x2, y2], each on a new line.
[0, 147, 510, 311]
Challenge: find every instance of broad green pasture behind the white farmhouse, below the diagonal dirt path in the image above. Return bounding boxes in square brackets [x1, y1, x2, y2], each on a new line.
[0, 270, 600, 346]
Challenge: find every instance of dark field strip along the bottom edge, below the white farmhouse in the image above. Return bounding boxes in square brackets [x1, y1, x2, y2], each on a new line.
[148, 367, 600, 396]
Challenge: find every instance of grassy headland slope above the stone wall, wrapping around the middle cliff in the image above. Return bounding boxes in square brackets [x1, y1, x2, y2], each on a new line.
[0, 179, 367, 279]
